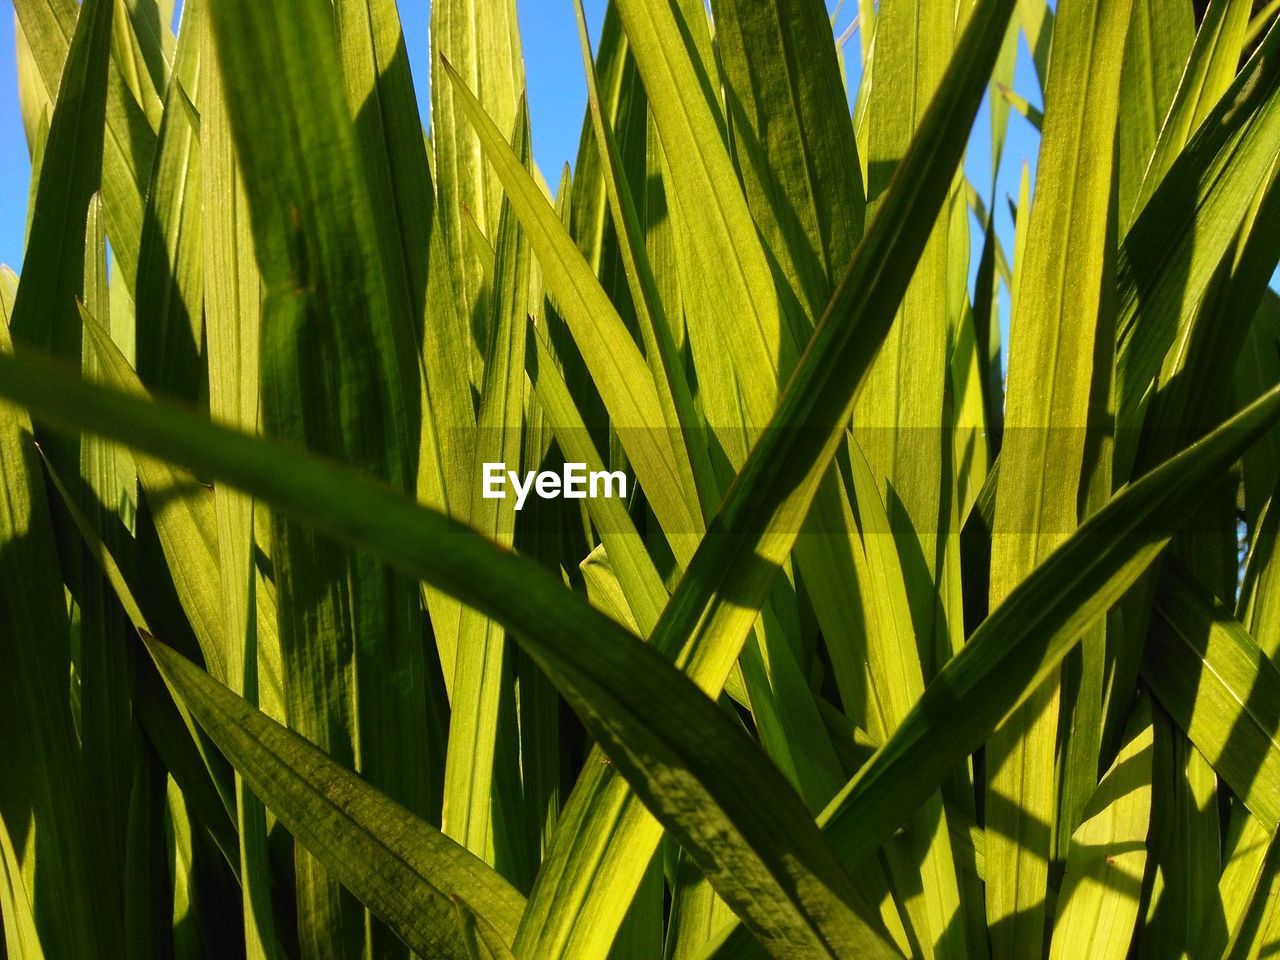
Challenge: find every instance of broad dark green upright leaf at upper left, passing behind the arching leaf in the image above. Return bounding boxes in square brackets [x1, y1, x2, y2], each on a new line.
[209, 0, 430, 956]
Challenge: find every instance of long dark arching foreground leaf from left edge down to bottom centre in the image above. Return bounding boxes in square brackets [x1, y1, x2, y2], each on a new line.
[0, 357, 893, 957]
